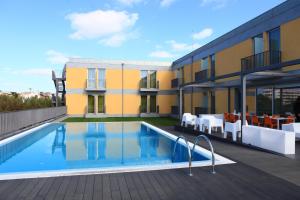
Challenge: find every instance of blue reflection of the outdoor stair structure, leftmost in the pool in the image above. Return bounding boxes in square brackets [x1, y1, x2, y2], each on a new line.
[52, 124, 66, 158]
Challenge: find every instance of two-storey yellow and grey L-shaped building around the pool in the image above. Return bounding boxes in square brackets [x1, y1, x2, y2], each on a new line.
[66, 0, 300, 116]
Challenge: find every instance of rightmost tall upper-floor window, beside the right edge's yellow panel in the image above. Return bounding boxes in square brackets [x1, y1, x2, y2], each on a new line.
[269, 28, 280, 64]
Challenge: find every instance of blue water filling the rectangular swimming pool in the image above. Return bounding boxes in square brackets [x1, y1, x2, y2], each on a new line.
[0, 122, 208, 174]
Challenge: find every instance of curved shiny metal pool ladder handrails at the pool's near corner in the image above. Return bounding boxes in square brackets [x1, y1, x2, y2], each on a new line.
[172, 135, 216, 176]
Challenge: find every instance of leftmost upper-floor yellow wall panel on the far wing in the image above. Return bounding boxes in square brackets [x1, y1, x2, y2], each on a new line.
[66, 67, 87, 89]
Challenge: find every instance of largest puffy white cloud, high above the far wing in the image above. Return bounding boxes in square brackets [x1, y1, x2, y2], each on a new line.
[66, 10, 139, 46]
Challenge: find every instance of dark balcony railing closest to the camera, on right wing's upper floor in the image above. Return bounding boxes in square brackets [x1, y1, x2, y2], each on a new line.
[241, 51, 281, 72]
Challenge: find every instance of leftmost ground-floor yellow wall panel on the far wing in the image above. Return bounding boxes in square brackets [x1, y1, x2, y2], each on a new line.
[66, 94, 88, 115]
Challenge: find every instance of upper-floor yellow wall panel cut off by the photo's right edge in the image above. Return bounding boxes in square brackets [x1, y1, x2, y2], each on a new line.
[280, 18, 300, 61]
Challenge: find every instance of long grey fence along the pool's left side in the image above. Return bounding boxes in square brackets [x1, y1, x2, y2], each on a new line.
[0, 106, 67, 136]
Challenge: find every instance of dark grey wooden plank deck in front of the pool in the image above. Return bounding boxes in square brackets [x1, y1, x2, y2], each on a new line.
[0, 128, 300, 200]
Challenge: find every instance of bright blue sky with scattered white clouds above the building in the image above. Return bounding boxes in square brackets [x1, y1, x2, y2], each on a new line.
[0, 0, 283, 92]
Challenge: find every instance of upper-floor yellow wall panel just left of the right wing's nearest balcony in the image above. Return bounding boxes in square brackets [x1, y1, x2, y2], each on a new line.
[216, 39, 252, 76]
